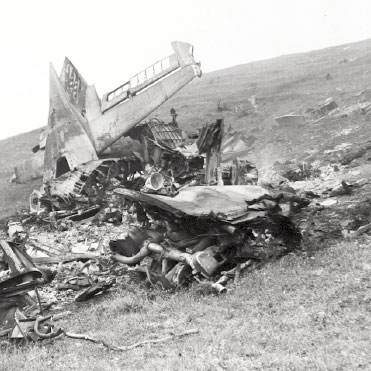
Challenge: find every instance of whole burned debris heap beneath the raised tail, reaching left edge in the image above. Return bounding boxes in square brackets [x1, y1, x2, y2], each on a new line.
[0, 110, 307, 346]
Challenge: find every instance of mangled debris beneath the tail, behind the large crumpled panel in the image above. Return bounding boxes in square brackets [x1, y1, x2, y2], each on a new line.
[30, 119, 258, 221]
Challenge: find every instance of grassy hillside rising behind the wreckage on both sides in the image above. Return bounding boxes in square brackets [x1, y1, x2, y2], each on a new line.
[0, 39, 371, 217]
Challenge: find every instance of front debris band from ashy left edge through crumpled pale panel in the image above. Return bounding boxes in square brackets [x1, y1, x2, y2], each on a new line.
[0, 185, 301, 340]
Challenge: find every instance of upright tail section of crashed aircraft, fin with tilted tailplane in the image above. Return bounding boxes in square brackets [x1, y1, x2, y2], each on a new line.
[44, 41, 201, 182]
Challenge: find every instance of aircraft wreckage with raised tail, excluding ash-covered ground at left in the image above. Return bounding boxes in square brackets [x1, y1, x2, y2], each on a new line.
[0, 42, 308, 342]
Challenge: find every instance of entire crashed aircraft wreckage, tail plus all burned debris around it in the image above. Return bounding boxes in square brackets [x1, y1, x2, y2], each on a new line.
[0, 42, 316, 350]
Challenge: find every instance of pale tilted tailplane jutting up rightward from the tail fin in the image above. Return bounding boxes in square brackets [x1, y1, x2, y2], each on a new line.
[86, 41, 201, 154]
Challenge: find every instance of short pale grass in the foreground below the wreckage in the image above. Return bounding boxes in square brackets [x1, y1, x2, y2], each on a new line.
[0, 239, 371, 371]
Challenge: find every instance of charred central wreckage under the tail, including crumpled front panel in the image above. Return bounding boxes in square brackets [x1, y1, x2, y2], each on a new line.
[29, 115, 300, 292]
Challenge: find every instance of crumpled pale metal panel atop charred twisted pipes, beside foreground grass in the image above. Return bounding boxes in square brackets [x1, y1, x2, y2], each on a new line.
[110, 185, 301, 292]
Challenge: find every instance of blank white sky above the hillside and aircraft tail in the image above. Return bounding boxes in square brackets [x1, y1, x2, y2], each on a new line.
[0, 0, 371, 139]
